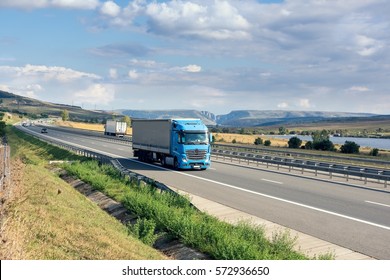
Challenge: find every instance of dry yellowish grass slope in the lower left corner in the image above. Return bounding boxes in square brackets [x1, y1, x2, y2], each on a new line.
[0, 123, 166, 260]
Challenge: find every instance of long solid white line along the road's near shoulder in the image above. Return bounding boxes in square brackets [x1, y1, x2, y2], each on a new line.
[23, 127, 390, 230]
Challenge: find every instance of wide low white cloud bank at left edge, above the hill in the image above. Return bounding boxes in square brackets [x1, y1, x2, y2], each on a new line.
[0, 64, 108, 107]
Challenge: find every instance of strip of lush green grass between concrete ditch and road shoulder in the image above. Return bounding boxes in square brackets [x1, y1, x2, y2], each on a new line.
[65, 162, 312, 260]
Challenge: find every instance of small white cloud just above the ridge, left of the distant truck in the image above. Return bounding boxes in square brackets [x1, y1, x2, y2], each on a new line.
[73, 84, 115, 105]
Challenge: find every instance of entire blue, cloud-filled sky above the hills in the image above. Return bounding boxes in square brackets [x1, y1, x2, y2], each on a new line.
[0, 0, 390, 115]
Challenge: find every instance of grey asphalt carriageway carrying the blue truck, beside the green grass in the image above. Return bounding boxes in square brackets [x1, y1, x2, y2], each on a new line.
[24, 126, 390, 260]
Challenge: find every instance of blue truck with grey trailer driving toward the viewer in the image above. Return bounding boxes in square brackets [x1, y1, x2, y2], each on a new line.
[132, 119, 212, 170]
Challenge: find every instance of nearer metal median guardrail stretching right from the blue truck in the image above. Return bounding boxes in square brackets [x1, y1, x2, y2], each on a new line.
[212, 148, 390, 188]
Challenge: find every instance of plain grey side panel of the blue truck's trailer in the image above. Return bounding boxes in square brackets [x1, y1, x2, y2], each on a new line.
[132, 119, 171, 154]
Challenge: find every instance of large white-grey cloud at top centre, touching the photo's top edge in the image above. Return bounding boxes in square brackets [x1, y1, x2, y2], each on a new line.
[145, 0, 250, 40]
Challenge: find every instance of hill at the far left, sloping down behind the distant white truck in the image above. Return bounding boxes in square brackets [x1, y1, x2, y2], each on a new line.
[0, 90, 112, 122]
